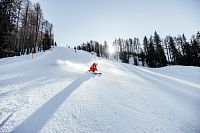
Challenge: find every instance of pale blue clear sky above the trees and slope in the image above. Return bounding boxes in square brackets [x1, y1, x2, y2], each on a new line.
[31, 0, 200, 46]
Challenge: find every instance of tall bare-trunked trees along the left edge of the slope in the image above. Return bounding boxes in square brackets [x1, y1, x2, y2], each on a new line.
[0, 0, 55, 58]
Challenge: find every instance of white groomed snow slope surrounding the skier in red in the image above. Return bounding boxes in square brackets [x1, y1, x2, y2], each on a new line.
[0, 47, 200, 133]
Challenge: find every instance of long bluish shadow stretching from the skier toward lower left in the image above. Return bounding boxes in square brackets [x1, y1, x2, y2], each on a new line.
[12, 73, 94, 133]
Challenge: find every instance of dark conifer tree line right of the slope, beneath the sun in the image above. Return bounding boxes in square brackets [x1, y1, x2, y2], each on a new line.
[77, 31, 200, 68]
